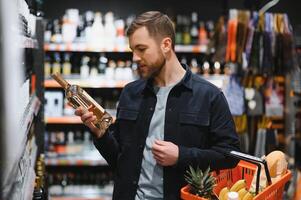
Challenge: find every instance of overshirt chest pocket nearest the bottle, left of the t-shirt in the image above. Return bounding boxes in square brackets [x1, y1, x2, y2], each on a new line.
[117, 108, 139, 147]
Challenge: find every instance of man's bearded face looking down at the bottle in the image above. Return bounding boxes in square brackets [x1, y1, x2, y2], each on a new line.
[129, 27, 165, 79]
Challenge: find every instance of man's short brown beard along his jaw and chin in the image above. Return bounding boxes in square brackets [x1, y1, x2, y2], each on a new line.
[138, 52, 166, 79]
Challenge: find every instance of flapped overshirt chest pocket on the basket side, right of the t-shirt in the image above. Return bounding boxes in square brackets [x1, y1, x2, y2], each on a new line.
[179, 112, 210, 147]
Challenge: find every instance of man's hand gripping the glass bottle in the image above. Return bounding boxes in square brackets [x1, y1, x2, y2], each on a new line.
[75, 106, 103, 138]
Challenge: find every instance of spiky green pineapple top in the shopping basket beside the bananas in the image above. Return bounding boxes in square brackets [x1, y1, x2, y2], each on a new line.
[184, 166, 215, 199]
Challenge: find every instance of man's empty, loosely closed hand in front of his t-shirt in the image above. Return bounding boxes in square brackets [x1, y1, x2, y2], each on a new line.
[152, 140, 179, 166]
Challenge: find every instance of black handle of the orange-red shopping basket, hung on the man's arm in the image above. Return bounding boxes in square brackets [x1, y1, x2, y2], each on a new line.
[225, 151, 272, 195]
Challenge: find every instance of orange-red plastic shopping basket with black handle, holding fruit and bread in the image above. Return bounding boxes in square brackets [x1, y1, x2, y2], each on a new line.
[181, 151, 292, 200]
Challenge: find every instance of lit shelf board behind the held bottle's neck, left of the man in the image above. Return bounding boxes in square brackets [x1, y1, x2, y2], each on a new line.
[44, 79, 130, 88]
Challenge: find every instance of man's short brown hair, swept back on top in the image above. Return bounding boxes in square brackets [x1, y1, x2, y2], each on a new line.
[126, 11, 175, 49]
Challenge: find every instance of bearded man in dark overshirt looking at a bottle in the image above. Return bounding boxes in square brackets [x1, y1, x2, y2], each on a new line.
[76, 11, 239, 200]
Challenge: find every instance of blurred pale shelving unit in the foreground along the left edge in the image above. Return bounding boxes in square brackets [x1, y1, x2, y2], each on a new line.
[0, 1, 44, 200]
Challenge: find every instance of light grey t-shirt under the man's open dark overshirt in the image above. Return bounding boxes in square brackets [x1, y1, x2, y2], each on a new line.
[135, 85, 174, 200]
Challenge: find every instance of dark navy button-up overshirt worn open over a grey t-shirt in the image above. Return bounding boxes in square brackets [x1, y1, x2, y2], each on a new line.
[94, 66, 239, 200]
